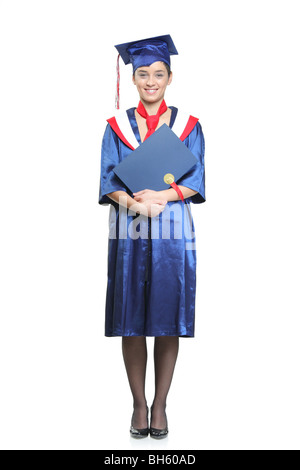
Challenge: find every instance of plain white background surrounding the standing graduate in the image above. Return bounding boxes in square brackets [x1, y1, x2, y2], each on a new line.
[0, 0, 300, 450]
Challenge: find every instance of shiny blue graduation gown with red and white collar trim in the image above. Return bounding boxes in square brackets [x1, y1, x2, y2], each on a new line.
[98, 107, 205, 337]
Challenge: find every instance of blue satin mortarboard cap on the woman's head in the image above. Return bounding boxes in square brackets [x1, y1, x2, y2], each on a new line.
[115, 34, 178, 72]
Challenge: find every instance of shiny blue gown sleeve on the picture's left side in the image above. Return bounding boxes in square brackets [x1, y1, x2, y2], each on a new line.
[98, 124, 126, 204]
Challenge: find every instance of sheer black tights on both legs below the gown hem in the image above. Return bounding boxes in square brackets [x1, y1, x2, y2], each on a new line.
[122, 336, 179, 429]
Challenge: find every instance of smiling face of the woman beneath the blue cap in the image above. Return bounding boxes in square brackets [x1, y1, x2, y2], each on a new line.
[132, 62, 172, 103]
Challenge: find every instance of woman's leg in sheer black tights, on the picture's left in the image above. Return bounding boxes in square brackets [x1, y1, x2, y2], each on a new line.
[122, 336, 148, 429]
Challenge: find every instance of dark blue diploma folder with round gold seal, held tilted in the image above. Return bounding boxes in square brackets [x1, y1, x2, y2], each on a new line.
[113, 124, 198, 193]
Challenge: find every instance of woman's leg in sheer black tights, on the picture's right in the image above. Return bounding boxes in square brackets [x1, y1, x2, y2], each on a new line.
[151, 336, 179, 429]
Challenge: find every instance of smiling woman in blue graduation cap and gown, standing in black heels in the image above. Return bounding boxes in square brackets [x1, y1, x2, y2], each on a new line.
[99, 35, 205, 438]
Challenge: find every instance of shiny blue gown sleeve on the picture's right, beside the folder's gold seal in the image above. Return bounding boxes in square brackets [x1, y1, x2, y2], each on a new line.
[177, 122, 206, 204]
